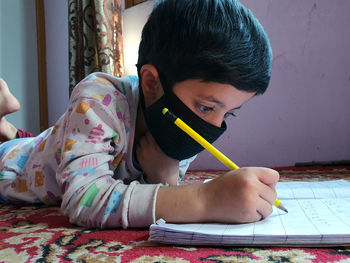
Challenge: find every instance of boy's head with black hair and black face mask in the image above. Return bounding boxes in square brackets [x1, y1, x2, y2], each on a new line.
[137, 0, 272, 160]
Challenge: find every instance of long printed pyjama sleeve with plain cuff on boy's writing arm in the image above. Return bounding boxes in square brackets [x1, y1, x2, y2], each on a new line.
[55, 82, 159, 228]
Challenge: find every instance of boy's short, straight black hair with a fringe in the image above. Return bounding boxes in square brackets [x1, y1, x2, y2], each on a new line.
[137, 0, 272, 94]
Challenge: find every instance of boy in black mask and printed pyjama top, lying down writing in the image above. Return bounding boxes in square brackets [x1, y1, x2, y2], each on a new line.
[0, 0, 278, 228]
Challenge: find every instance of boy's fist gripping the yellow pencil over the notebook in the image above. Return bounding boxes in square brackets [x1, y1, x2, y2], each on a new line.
[201, 167, 279, 223]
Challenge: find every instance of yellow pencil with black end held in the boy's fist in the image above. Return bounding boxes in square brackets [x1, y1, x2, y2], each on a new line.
[162, 108, 288, 213]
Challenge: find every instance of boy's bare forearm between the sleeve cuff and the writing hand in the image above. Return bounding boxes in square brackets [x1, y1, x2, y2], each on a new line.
[156, 185, 206, 223]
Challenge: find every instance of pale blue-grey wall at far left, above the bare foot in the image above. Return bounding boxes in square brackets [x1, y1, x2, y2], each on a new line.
[0, 0, 40, 133]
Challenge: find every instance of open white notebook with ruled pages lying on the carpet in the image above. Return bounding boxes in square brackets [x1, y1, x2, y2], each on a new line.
[149, 180, 350, 246]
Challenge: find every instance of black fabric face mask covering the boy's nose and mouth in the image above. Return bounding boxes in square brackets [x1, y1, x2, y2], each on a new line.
[140, 78, 226, 161]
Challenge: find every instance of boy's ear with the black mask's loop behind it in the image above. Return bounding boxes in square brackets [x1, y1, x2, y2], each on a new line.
[140, 64, 164, 107]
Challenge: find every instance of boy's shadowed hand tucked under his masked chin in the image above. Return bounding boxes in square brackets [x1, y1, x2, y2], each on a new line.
[136, 132, 179, 185]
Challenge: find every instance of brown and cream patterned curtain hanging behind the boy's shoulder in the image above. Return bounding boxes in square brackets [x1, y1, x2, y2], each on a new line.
[68, 0, 124, 93]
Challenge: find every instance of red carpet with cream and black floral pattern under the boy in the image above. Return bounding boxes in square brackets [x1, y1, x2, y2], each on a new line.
[0, 166, 350, 263]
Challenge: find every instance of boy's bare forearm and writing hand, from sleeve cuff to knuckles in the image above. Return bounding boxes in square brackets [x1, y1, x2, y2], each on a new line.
[156, 167, 279, 223]
